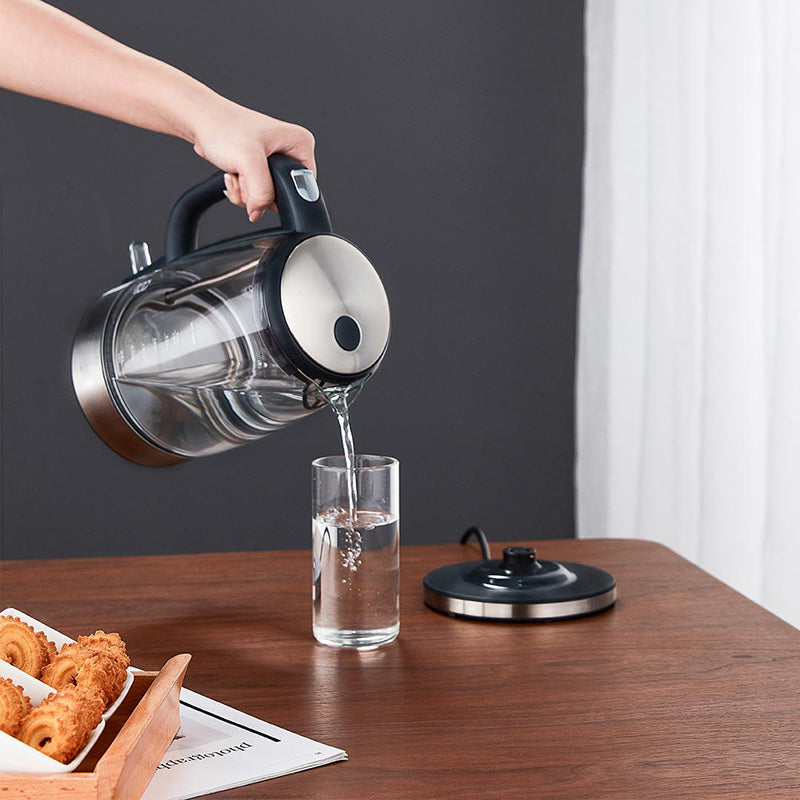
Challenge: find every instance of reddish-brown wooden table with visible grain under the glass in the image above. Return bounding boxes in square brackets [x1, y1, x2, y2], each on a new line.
[0, 540, 800, 800]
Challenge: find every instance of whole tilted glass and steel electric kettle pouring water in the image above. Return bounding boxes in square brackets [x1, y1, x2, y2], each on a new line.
[72, 154, 389, 466]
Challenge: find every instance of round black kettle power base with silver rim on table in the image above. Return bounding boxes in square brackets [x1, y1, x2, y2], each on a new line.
[423, 547, 617, 622]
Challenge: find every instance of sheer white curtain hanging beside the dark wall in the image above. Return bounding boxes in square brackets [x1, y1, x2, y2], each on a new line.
[576, 0, 800, 627]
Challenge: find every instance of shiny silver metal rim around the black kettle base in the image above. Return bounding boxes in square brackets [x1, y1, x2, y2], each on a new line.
[424, 586, 617, 622]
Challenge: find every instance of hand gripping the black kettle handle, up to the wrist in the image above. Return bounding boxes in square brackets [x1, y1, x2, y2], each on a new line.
[192, 98, 317, 222]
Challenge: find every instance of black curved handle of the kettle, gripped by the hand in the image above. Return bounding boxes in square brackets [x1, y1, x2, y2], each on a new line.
[164, 153, 331, 261]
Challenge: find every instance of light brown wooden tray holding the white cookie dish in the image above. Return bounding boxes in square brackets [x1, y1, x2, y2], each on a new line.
[0, 655, 191, 800]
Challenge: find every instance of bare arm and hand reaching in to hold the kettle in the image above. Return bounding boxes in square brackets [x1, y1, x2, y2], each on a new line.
[0, 0, 316, 220]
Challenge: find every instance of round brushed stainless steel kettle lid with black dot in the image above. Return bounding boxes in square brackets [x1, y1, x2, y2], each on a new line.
[278, 234, 390, 379]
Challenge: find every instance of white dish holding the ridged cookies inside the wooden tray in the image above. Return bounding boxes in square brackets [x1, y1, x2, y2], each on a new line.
[0, 608, 133, 773]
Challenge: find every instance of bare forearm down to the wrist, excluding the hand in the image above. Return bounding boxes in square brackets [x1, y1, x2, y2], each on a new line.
[0, 0, 227, 142]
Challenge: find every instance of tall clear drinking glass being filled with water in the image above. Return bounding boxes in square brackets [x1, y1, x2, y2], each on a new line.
[311, 455, 400, 649]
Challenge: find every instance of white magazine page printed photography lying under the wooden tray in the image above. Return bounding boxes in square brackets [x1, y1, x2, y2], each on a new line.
[142, 689, 347, 800]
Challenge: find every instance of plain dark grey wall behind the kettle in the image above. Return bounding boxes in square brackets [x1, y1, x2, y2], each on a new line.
[0, 0, 583, 558]
